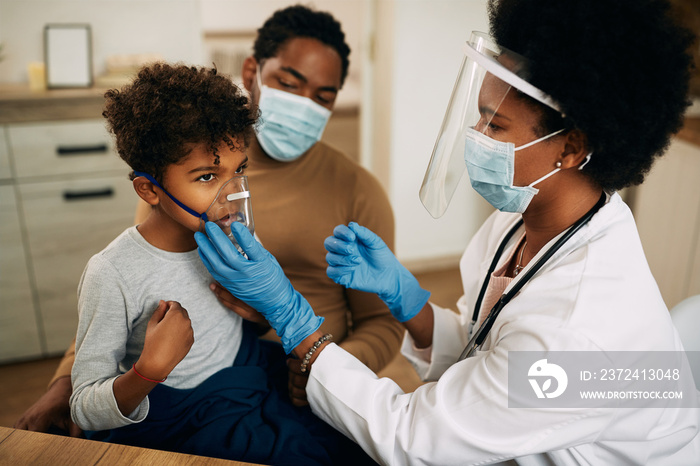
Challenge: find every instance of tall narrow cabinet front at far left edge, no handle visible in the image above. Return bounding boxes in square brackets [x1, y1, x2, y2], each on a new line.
[0, 186, 42, 363]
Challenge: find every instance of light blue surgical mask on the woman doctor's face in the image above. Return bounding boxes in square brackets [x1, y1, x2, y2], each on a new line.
[464, 128, 568, 213]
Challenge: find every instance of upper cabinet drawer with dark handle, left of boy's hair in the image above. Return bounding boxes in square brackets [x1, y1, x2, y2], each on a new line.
[8, 120, 128, 178]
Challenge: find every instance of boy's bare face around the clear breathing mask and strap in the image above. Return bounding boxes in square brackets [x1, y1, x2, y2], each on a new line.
[159, 139, 248, 237]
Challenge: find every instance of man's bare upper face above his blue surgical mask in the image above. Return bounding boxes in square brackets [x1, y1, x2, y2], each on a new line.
[247, 37, 342, 110]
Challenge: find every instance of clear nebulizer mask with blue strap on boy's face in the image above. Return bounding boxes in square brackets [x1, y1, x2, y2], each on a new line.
[134, 171, 255, 254]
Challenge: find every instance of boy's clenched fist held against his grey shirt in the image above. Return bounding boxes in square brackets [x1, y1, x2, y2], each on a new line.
[136, 301, 194, 380]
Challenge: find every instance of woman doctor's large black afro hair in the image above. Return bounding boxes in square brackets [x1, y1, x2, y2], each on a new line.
[489, 0, 694, 190]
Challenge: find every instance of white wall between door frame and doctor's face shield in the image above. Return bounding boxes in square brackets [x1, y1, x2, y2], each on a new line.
[374, 0, 491, 269]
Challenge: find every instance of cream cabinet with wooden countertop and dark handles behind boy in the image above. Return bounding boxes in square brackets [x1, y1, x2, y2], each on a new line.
[0, 86, 137, 363]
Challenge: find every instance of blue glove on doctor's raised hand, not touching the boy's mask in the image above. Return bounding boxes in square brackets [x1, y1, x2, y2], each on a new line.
[323, 222, 430, 322]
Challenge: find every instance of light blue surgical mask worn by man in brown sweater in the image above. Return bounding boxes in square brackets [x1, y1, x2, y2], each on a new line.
[255, 68, 331, 162]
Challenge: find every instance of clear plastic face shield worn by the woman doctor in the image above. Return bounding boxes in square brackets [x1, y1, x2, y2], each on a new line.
[420, 32, 559, 218]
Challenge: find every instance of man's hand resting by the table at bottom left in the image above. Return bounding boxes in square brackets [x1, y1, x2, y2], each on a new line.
[13, 376, 83, 437]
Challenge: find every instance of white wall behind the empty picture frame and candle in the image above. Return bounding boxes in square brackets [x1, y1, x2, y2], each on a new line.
[0, 0, 203, 83]
